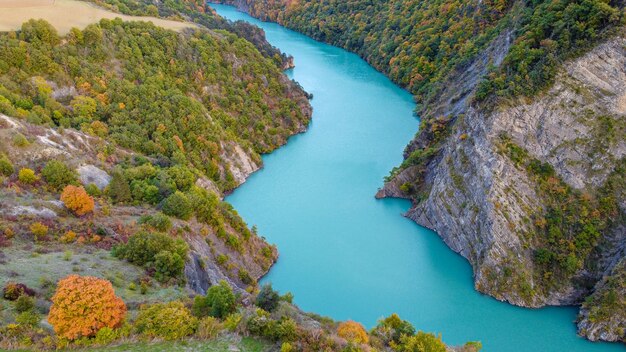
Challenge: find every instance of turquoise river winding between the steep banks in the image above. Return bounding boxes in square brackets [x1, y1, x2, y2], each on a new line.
[211, 5, 624, 352]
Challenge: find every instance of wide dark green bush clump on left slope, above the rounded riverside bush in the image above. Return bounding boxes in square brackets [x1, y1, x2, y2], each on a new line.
[113, 232, 189, 282]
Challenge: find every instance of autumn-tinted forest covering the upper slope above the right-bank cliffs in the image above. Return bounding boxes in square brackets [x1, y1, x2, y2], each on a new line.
[221, 0, 623, 102]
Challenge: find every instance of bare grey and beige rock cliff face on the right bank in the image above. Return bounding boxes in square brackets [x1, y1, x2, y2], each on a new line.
[378, 36, 626, 341]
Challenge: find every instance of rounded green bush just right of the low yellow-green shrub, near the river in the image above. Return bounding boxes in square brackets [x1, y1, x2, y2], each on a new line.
[191, 280, 236, 318]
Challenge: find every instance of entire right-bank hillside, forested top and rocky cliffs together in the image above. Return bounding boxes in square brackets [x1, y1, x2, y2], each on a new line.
[214, 0, 626, 341]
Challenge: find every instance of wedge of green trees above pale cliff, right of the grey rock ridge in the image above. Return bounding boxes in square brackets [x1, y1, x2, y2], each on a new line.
[476, 0, 623, 100]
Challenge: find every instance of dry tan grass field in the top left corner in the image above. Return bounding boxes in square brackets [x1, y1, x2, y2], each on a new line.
[0, 0, 194, 35]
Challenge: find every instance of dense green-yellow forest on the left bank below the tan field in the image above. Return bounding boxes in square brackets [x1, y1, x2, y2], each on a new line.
[0, 20, 308, 190]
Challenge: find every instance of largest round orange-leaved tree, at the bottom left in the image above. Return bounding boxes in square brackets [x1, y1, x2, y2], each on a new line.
[48, 275, 126, 340]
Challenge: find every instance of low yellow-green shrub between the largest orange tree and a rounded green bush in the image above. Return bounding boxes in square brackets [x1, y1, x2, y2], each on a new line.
[135, 302, 198, 340]
